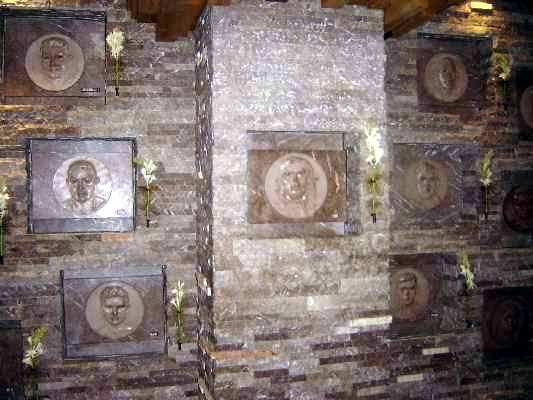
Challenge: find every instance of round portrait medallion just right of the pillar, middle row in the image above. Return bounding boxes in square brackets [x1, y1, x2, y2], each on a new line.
[404, 160, 448, 210]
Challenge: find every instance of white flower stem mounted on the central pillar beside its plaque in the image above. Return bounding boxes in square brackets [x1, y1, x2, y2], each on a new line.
[365, 121, 385, 222]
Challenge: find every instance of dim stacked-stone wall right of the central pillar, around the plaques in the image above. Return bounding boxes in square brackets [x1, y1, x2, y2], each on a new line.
[385, 1, 533, 399]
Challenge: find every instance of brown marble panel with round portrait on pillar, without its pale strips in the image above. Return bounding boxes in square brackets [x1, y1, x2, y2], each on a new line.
[248, 150, 346, 224]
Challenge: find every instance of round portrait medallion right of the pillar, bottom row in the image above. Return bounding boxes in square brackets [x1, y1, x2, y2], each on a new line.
[391, 268, 430, 322]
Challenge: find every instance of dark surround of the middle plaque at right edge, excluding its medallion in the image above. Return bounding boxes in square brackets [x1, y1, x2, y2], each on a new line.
[501, 171, 533, 247]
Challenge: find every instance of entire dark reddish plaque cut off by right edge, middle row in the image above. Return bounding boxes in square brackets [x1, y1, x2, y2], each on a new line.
[501, 171, 533, 247]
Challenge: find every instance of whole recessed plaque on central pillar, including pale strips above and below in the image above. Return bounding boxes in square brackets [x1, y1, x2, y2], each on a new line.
[247, 132, 359, 237]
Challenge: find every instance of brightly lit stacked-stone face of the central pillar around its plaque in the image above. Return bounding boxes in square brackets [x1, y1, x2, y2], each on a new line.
[199, 0, 390, 399]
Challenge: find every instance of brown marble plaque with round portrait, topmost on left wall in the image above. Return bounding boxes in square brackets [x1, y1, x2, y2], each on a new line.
[2, 15, 105, 103]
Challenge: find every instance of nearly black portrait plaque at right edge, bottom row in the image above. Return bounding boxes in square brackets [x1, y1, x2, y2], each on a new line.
[482, 287, 533, 361]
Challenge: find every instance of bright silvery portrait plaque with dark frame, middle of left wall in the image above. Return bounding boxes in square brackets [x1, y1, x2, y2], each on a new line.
[26, 138, 136, 233]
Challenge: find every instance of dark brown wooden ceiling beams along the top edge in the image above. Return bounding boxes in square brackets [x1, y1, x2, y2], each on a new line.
[128, 0, 465, 41]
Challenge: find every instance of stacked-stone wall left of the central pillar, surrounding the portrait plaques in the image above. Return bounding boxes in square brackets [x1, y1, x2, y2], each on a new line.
[0, 0, 197, 400]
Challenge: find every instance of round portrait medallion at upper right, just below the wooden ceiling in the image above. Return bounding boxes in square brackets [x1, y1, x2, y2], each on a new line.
[423, 53, 468, 103]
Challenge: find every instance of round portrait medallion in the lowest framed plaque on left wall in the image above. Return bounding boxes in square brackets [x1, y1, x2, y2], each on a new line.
[85, 281, 144, 339]
